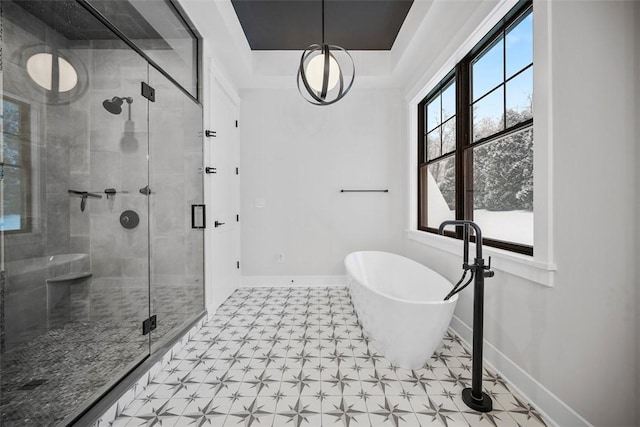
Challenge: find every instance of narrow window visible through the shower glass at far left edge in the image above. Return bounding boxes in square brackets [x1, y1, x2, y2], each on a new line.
[0, 96, 31, 232]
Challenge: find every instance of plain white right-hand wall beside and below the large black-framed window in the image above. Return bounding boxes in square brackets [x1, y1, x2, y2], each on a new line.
[405, 1, 640, 426]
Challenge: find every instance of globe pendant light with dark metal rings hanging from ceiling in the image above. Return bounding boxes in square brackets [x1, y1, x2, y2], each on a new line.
[297, 0, 356, 105]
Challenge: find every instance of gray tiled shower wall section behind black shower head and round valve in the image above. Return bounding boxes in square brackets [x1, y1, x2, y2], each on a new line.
[76, 46, 149, 322]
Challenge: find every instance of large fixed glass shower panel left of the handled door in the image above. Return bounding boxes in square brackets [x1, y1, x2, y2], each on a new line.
[0, 0, 151, 426]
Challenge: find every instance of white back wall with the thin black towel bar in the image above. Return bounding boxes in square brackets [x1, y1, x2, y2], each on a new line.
[240, 88, 405, 276]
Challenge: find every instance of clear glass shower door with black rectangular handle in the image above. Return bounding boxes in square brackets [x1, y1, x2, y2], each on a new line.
[149, 67, 204, 350]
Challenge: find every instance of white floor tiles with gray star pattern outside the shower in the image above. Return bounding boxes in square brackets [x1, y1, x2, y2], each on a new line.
[112, 287, 549, 427]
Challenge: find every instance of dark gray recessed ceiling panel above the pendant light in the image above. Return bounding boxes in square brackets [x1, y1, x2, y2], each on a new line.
[231, 0, 413, 50]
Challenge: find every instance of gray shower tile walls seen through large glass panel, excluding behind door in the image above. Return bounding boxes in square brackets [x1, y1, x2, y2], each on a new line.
[3, 2, 149, 340]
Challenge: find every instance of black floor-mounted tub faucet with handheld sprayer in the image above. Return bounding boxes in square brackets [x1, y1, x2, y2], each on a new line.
[438, 220, 494, 412]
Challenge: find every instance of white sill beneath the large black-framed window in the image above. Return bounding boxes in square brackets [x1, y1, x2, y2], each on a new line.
[405, 230, 558, 286]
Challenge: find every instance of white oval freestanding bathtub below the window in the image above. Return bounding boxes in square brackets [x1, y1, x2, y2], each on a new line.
[344, 251, 458, 369]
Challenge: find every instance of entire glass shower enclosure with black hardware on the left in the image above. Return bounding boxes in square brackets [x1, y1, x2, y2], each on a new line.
[0, 0, 204, 426]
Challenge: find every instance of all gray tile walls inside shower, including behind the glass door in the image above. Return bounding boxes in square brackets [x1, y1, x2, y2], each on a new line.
[3, 2, 204, 354]
